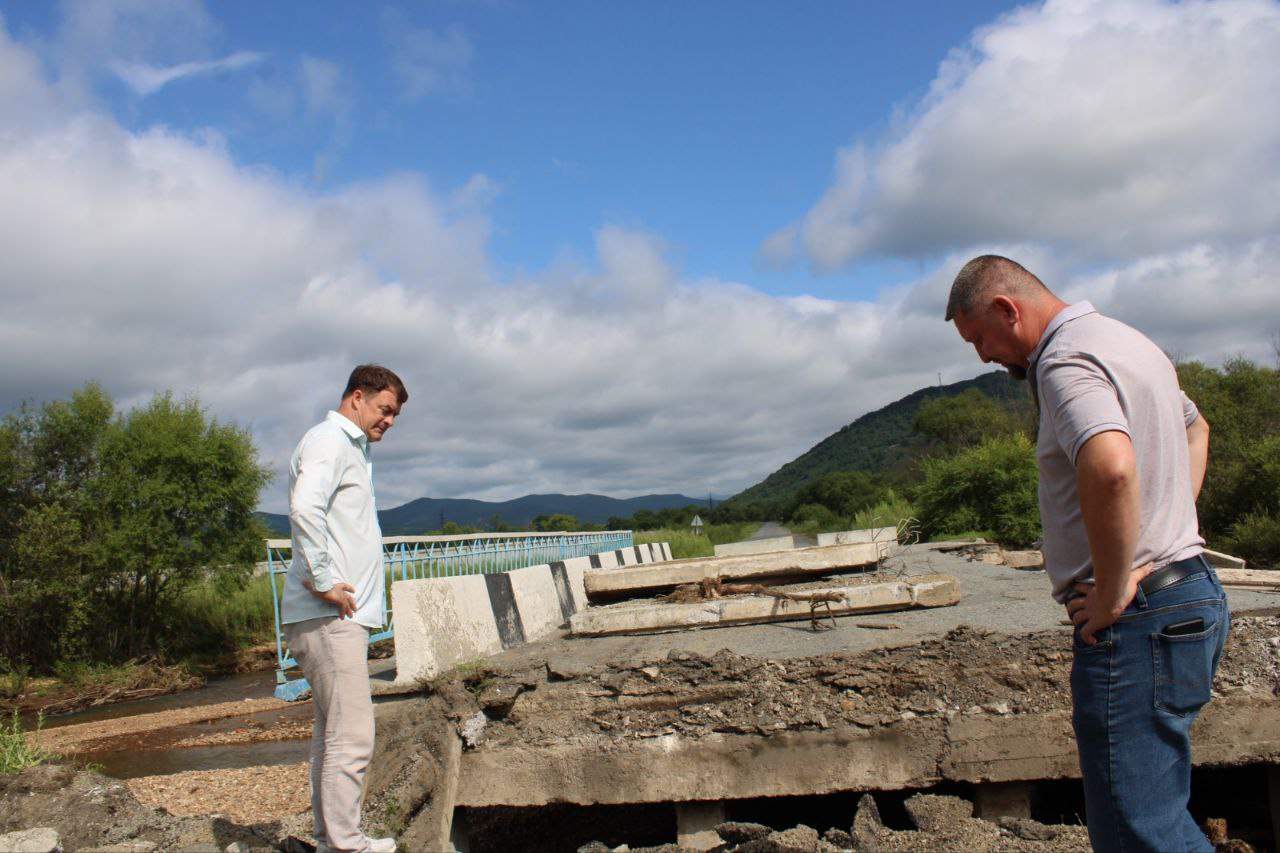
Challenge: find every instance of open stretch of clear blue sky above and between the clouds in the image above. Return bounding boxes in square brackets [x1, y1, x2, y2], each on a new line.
[6, 0, 1012, 298]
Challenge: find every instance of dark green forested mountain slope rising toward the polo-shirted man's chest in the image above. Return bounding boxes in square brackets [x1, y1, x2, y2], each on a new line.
[730, 370, 1029, 503]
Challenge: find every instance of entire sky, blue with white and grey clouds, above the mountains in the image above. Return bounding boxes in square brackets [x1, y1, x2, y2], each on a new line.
[0, 0, 1280, 511]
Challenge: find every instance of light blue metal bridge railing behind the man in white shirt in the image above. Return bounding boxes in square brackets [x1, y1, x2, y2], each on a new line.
[266, 530, 634, 699]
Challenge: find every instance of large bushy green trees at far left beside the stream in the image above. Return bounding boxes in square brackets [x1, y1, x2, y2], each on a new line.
[0, 384, 270, 670]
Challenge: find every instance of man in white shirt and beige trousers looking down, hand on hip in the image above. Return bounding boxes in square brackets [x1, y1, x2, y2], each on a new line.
[280, 365, 408, 853]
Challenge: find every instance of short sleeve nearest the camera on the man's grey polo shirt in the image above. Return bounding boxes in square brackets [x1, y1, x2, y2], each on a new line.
[1036, 352, 1129, 465]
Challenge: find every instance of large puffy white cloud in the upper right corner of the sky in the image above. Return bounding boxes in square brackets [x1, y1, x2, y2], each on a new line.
[778, 0, 1280, 269]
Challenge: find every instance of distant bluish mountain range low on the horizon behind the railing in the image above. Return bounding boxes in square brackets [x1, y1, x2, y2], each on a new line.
[257, 494, 718, 537]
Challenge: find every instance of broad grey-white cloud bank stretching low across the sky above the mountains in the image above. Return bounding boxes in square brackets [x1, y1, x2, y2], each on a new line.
[0, 6, 1280, 517]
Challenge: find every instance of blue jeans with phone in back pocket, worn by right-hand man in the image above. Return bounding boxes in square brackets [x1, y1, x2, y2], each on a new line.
[1071, 564, 1230, 853]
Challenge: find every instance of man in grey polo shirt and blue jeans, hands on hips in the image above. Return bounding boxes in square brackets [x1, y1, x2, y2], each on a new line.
[946, 255, 1229, 850]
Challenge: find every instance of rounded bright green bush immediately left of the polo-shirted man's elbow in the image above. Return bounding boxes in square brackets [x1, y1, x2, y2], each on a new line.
[915, 433, 1041, 546]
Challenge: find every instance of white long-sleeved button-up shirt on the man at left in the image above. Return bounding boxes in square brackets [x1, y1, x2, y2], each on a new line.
[288, 411, 387, 629]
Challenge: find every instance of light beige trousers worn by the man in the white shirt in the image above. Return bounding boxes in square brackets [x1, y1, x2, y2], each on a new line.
[284, 616, 374, 852]
